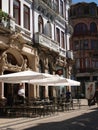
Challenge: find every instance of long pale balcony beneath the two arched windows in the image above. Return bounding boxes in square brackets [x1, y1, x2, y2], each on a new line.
[34, 32, 59, 53]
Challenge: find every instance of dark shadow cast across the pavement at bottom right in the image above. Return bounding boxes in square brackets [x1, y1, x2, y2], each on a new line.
[24, 108, 98, 130]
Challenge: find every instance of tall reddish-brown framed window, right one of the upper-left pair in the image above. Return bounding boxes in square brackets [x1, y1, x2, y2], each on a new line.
[24, 5, 30, 30]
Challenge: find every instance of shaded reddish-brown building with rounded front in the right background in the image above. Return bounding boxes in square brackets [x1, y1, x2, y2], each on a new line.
[69, 2, 98, 94]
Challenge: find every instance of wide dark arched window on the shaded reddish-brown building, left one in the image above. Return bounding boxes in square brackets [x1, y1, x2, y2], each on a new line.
[74, 23, 88, 33]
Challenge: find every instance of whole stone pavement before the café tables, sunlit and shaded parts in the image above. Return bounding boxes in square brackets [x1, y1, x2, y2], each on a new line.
[0, 105, 98, 130]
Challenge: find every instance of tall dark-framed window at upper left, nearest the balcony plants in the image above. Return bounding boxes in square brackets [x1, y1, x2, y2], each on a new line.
[13, 0, 20, 25]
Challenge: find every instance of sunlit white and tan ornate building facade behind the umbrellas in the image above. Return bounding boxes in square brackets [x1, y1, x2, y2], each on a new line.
[0, 0, 73, 99]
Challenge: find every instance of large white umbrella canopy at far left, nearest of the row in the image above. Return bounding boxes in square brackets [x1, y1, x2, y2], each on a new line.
[0, 70, 53, 83]
